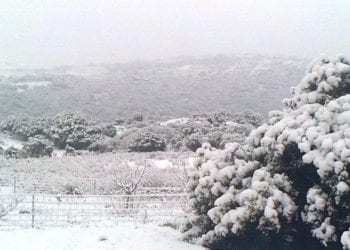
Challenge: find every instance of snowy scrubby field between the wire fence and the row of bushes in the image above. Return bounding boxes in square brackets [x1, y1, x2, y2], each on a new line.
[0, 152, 194, 194]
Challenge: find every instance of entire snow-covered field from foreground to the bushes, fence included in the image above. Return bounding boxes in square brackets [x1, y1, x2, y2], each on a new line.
[0, 150, 196, 250]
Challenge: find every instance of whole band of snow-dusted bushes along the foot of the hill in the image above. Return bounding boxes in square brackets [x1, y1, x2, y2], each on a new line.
[0, 112, 263, 158]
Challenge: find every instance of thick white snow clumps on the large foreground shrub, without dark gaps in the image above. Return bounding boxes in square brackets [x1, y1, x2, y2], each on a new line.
[182, 57, 350, 249]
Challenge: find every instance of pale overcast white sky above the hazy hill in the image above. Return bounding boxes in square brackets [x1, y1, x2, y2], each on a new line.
[0, 0, 350, 67]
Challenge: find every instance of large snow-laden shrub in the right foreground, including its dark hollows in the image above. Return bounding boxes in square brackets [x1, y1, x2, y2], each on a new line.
[182, 57, 350, 250]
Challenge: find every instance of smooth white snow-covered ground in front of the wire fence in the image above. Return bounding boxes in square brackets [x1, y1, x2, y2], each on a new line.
[0, 223, 205, 250]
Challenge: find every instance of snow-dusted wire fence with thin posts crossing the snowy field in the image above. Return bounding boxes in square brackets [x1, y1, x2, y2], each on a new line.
[0, 193, 186, 230]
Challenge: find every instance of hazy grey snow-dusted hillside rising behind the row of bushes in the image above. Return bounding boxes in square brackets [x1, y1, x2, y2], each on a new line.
[0, 56, 307, 121]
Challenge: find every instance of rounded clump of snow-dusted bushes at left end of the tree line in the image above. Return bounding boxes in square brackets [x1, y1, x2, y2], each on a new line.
[0, 112, 117, 157]
